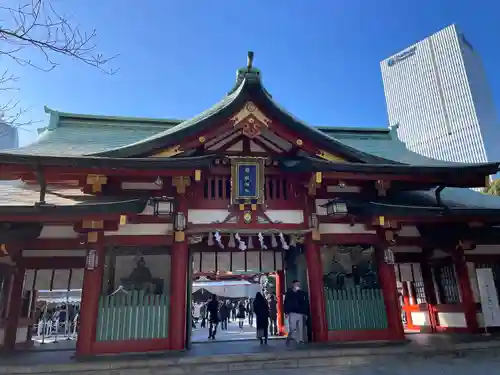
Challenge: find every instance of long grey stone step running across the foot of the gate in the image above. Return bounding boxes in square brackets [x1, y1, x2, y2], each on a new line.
[0, 340, 500, 375]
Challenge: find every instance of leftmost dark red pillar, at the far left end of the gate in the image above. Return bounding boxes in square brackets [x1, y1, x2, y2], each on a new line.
[4, 267, 26, 350]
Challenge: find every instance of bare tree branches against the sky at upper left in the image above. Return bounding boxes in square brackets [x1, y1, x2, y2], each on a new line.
[0, 0, 117, 136]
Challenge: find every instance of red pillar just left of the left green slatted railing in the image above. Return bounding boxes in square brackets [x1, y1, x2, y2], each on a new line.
[76, 232, 105, 356]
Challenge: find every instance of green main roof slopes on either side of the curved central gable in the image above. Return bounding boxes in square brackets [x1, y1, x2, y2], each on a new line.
[8, 110, 494, 165]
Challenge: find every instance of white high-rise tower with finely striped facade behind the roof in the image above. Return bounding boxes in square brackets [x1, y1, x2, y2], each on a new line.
[380, 25, 500, 170]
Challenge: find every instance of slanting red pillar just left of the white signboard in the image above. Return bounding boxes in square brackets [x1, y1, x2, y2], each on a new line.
[451, 249, 479, 333]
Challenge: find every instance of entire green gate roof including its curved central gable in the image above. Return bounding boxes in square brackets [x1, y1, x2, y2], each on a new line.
[0, 58, 496, 166]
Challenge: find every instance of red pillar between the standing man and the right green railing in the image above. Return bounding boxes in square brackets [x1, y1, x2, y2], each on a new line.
[305, 233, 328, 342]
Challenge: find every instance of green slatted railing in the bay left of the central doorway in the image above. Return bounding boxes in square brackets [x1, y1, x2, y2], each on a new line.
[96, 291, 170, 341]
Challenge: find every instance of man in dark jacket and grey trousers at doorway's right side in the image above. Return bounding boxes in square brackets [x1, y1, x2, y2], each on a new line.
[284, 280, 309, 345]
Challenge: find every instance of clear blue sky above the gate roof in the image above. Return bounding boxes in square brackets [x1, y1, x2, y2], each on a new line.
[4, 0, 500, 144]
